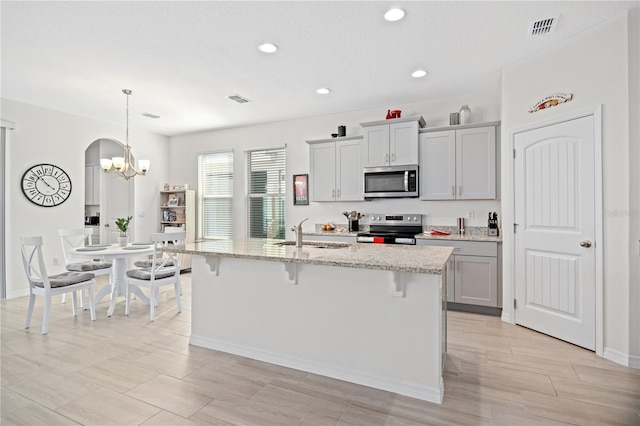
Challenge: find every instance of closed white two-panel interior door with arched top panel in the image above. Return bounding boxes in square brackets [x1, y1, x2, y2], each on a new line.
[514, 116, 597, 350]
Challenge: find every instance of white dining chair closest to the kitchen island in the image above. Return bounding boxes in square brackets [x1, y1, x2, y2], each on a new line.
[125, 231, 187, 321]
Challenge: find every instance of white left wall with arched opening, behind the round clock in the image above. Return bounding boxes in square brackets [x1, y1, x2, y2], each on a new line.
[1, 99, 169, 298]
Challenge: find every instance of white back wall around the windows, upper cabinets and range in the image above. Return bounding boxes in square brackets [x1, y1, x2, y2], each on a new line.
[170, 91, 500, 237]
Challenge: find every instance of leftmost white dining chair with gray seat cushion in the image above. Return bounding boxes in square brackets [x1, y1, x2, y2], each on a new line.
[20, 236, 96, 334]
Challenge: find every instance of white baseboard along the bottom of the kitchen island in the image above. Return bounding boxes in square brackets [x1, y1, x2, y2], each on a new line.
[189, 335, 444, 404]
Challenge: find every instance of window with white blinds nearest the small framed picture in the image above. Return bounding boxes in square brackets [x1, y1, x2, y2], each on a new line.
[247, 148, 286, 239]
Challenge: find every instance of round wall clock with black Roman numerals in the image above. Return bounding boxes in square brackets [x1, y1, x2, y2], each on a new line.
[22, 164, 71, 207]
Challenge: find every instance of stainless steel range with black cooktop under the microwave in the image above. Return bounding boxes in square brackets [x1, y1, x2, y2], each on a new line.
[356, 214, 422, 245]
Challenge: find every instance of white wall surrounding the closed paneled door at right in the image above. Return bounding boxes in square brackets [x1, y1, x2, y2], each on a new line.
[502, 11, 640, 358]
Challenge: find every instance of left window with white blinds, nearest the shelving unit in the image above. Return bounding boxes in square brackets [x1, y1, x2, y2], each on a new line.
[198, 151, 233, 239]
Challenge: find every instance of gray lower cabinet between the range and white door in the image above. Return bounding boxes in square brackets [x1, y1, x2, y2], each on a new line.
[417, 239, 502, 315]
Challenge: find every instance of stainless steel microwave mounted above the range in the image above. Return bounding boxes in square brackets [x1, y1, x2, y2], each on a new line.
[363, 164, 419, 200]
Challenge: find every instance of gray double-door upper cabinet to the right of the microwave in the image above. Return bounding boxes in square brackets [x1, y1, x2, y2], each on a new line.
[420, 123, 498, 200]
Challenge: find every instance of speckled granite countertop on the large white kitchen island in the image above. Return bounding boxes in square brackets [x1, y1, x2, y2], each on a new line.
[164, 238, 453, 275]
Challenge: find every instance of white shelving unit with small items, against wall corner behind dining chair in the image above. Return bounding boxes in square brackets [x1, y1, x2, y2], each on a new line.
[160, 187, 196, 269]
